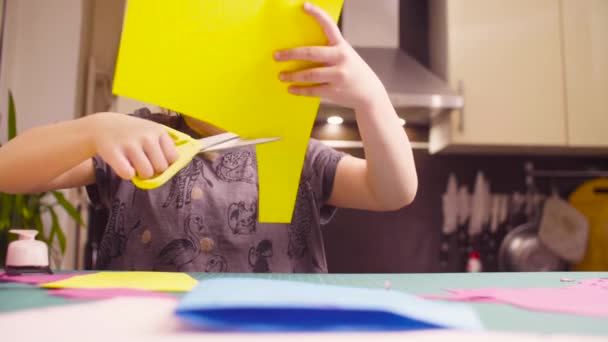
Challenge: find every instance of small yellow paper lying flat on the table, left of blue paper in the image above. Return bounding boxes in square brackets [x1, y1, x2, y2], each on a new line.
[40, 272, 198, 292]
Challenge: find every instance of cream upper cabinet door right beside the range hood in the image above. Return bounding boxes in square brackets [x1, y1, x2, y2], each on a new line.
[431, 0, 566, 151]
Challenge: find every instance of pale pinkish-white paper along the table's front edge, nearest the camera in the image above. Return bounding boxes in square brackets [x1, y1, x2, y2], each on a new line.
[0, 298, 592, 342]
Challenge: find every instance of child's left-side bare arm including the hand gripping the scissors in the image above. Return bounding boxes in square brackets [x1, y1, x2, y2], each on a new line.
[0, 113, 177, 193]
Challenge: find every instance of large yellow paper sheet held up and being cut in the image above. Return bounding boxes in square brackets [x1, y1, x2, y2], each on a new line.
[114, 0, 343, 223]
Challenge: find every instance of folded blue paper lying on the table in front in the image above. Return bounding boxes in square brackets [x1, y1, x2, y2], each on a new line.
[176, 278, 482, 332]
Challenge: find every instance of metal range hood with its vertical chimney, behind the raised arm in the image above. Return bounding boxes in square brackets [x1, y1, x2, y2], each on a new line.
[317, 0, 464, 125]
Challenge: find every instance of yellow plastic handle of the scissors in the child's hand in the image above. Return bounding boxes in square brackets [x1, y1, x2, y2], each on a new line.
[133, 126, 201, 190]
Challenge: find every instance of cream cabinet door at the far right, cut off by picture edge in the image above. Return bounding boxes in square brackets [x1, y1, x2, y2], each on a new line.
[562, 0, 608, 147]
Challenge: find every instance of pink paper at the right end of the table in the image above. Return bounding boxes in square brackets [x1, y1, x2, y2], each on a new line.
[424, 279, 608, 317]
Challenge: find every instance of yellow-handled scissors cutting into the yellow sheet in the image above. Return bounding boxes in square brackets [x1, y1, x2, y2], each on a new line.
[132, 126, 281, 190]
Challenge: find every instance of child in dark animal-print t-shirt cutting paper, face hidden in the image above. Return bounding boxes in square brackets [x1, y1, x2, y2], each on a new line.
[0, 3, 417, 272]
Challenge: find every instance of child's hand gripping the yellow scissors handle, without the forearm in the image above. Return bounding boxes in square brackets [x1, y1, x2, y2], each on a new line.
[92, 113, 178, 180]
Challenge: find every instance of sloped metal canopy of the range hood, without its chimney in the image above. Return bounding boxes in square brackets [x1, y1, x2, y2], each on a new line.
[318, 47, 464, 125]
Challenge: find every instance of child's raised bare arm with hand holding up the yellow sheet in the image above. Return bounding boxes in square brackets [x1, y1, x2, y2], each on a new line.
[275, 3, 418, 210]
